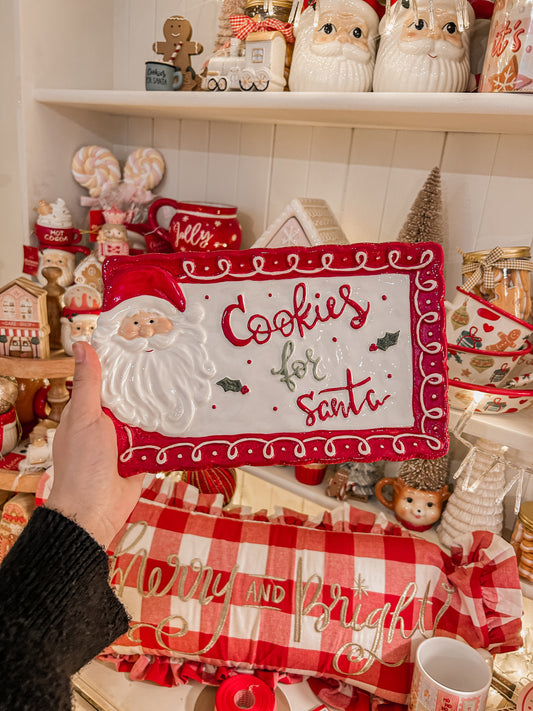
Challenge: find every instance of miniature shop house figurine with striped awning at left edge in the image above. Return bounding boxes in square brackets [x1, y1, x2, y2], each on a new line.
[0, 277, 50, 358]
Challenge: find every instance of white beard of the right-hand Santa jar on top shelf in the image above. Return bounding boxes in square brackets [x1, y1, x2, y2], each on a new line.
[373, 29, 470, 92]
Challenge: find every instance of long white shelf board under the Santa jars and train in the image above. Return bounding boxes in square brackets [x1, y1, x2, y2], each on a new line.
[33, 88, 533, 134]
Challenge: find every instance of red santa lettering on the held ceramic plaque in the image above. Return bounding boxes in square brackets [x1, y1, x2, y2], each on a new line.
[296, 368, 390, 427]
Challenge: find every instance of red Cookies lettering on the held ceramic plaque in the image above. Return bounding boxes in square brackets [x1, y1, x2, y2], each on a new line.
[221, 283, 370, 346]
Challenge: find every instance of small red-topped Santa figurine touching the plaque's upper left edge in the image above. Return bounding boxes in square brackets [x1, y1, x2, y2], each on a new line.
[61, 284, 102, 356]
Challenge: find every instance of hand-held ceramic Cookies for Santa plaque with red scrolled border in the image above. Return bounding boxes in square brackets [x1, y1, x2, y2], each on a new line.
[92, 243, 448, 475]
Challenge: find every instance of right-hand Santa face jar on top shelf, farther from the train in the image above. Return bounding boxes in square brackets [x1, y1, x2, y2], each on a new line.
[373, 0, 475, 92]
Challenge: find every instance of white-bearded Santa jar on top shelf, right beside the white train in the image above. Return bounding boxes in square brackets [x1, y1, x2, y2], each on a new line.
[289, 0, 381, 91]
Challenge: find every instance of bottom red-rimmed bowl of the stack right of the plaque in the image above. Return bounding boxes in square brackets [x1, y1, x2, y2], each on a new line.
[448, 380, 533, 415]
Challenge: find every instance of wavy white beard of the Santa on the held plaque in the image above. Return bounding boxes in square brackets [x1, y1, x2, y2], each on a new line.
[91, 307, 215, 437]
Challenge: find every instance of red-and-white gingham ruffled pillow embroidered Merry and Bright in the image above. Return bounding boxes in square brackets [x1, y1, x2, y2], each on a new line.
[102, 475, 522, 704]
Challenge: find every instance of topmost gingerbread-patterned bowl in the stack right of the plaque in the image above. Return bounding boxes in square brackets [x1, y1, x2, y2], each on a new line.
[444, 286, 533, 352]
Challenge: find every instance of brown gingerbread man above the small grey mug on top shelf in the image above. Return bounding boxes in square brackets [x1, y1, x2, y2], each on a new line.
[152, 15, 204, 91]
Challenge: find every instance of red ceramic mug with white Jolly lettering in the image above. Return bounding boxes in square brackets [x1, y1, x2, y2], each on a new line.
[148, 198, 242, 252]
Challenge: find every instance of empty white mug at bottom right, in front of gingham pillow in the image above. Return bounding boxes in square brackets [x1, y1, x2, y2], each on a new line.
[409, 637, 492, 711]
